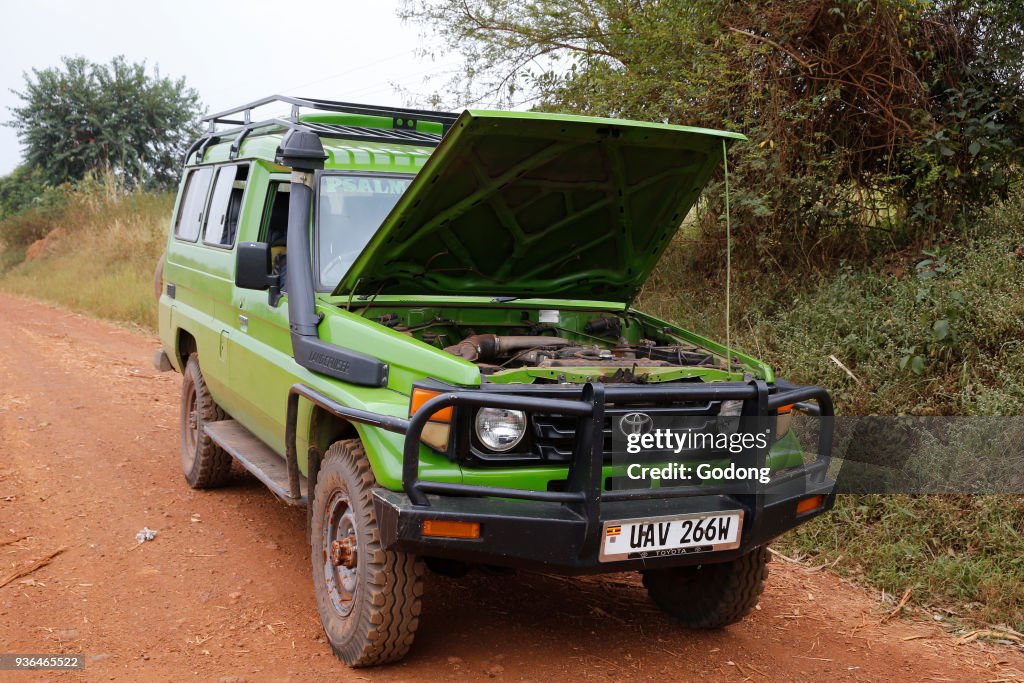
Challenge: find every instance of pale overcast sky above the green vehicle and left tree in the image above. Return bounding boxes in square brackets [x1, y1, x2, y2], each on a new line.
[0, 0, 460, 175]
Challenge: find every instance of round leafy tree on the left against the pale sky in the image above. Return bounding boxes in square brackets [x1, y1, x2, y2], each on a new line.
[7, 57, 201, 186]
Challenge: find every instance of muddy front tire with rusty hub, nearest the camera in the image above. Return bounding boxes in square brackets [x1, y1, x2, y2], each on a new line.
[309, 439, 423, 667]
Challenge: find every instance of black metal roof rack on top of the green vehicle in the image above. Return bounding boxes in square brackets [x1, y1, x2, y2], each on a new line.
[185, 95, 459, 163]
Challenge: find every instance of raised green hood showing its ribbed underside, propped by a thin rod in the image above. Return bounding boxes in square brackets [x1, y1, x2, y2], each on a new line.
[336, 111, 743, 303]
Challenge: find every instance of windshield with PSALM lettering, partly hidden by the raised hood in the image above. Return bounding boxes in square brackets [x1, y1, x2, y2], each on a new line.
[316, 174, 413, 290]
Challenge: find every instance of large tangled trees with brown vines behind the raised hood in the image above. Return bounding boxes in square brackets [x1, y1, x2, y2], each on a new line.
[402, 0, 1024, 264]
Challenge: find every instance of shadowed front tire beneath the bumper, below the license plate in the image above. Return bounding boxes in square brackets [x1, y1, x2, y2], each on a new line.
[643, 547, 769, 629]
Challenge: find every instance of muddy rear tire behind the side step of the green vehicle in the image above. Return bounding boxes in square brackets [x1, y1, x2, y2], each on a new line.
[180, 353, 231, 488]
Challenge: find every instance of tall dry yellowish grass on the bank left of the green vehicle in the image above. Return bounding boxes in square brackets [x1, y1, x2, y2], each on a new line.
[0, 182, 174, 330]
